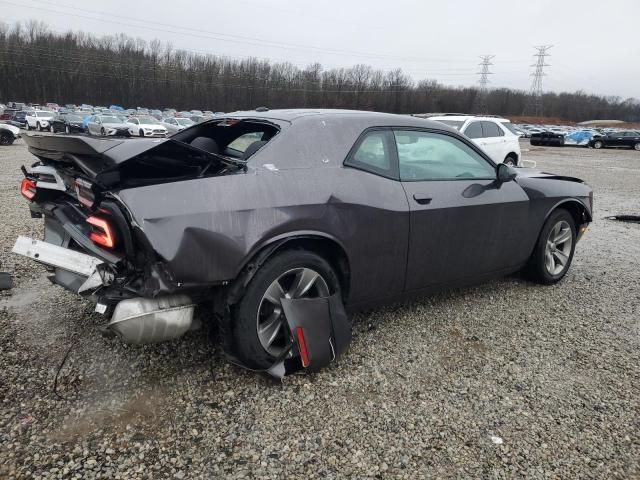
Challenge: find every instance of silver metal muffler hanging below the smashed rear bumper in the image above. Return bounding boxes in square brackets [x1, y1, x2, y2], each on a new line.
[107, 295, 195, 344]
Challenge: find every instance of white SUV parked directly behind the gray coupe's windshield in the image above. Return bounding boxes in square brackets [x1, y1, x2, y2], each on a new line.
[428, 115, 521, 165]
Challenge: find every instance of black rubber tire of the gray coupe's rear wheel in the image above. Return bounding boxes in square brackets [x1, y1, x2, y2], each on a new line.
[229, 250, 340, 369]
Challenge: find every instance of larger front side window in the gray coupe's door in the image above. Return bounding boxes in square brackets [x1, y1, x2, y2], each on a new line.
[394, 130, 495, 181]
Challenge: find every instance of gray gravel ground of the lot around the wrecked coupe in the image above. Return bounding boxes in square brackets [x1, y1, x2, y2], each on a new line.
[0, 137, 640, 479]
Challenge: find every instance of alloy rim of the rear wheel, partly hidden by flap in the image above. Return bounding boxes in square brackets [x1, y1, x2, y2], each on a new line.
[256, 267, 329, 357]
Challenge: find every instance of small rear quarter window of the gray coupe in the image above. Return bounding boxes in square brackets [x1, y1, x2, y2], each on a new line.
[345, 130, 397, 178]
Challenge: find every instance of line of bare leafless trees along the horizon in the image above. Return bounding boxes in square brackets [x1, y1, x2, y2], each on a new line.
[0, 21, 640, 122]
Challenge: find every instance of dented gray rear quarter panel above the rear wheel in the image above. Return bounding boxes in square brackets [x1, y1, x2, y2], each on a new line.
[119, 165, 409, 301]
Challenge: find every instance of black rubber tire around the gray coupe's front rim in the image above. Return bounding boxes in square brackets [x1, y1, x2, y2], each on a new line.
[525, 208, 576, 285]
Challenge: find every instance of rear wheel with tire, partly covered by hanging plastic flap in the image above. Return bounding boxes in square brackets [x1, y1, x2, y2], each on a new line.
[227, 250, 340, 369]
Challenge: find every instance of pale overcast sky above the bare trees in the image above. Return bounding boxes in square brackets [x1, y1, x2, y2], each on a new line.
[0, 0, 640, 98]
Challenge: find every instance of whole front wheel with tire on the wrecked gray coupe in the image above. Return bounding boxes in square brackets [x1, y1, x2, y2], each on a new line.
[527, 209, 576, 285]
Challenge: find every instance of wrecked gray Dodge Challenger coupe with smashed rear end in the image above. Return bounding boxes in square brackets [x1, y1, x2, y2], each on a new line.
[14, 109, 593, 369]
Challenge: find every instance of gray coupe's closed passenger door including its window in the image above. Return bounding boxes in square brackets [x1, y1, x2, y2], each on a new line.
[394, 129, 531, 291]
